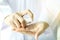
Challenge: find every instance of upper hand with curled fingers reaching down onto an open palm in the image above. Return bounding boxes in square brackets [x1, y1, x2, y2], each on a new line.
[4, 10, 33, 30]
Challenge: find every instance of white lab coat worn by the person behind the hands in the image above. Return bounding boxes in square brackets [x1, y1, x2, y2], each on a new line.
[0, 0, 59, 40]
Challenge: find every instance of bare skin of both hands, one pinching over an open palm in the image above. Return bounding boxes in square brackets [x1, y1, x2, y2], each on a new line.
[5, 10, 49, 40]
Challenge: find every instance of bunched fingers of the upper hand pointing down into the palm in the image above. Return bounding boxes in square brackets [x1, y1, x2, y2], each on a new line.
[4, 13, 26, 28]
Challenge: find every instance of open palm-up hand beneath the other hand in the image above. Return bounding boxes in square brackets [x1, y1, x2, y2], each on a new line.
[16, 22, 49, 40]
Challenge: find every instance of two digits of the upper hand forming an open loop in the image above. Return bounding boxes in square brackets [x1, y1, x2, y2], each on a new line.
[15, 10, 33, 27]
